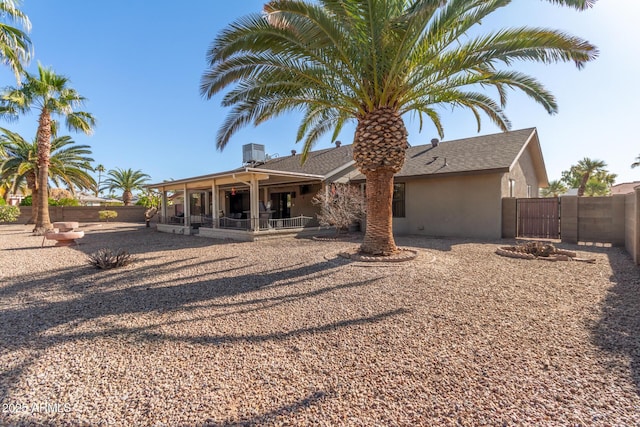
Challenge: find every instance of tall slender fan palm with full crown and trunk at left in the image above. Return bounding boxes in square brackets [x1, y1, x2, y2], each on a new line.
[0, 64, 95, 233]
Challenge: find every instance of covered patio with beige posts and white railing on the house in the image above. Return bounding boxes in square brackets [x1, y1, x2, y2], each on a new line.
[148, 167, 328, 241]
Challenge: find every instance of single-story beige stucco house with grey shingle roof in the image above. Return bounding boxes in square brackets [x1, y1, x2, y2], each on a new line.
[149, 128, 548, 240]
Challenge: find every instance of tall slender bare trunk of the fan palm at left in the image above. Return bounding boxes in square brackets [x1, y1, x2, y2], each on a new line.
[33, 108, 53, 234]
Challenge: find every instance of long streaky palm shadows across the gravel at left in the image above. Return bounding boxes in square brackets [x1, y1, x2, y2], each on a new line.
[0, 251, 403, 408]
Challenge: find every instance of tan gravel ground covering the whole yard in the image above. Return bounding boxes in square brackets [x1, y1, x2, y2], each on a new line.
[0, 223, 640, 426]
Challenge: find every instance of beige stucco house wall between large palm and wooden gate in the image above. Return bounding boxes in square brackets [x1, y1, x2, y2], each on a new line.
[393, 173, 503, 239]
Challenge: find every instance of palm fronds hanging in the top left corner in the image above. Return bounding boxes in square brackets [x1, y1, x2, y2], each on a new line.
[0, 0, 32, 84]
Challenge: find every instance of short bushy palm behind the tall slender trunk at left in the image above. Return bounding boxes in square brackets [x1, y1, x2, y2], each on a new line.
[0, 128, 96, 224]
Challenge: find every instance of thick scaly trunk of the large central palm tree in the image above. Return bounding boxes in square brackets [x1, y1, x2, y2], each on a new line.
[353, 107, 408, 255]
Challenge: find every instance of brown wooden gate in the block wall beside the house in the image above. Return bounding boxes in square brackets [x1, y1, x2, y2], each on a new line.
[516, 197, 560, 239]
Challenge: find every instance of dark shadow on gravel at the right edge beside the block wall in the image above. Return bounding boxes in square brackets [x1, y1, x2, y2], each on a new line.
[592, 248, 640, 395]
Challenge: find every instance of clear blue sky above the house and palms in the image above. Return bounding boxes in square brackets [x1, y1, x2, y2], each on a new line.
[0, 0, 640, 187]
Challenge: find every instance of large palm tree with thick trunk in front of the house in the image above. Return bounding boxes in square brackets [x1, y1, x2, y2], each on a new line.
[201, 0, 597, 254]
